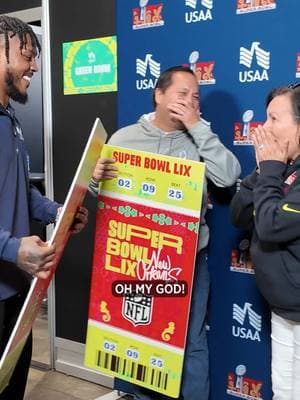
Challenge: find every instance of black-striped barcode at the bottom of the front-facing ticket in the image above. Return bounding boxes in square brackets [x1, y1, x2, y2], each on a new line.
[96, 350, 169, 390]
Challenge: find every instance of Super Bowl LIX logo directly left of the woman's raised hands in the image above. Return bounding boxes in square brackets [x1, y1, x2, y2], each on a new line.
[233, 110, 263, 146]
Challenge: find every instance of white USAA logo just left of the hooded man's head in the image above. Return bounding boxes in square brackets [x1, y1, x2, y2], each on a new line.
[136, 54, 160, 90]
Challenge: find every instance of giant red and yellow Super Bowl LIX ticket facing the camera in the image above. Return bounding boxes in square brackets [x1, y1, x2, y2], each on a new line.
[85, 145, 204, 397]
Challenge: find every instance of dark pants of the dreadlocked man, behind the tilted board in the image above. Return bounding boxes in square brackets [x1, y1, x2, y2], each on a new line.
[0, 294, 32, 400]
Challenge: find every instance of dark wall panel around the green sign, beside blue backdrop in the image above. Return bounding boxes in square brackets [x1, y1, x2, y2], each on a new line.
[50, 0, 116, 343]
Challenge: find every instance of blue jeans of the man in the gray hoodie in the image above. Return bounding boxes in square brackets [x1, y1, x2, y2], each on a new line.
[116, 250, 209, 400]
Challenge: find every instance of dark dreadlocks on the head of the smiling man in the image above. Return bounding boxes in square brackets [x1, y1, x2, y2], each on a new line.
[0, 15, 41, 63]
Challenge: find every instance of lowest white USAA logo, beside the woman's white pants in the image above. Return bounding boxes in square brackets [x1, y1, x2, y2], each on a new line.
[232, 303, 262, 342]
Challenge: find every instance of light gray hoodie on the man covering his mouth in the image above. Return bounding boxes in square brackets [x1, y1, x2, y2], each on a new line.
[103, 113, 241, 250]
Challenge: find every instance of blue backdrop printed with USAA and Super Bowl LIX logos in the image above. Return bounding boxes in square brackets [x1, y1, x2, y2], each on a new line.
[117, 0, 300, 400]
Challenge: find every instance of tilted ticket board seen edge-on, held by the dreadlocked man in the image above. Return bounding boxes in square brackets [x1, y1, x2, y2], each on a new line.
[0, 118, 107, 393]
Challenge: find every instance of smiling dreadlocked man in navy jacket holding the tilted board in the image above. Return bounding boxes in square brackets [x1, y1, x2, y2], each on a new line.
[0, 16, 87, 400]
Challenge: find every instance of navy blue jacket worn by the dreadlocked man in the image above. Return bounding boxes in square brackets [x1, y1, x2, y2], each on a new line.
[0, 105, 59, 300]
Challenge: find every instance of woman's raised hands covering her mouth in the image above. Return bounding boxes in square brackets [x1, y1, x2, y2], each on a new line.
[251, 125, 289, 166]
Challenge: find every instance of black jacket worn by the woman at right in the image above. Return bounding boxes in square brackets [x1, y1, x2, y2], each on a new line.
[230, 156, 300, 322]
